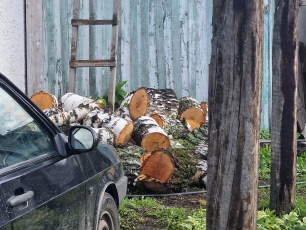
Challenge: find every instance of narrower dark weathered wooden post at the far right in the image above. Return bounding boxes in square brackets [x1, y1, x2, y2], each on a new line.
[270, 0, 299, 215]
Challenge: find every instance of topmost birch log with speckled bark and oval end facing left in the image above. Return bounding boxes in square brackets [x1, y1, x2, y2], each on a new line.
[129, 87, 179, 120]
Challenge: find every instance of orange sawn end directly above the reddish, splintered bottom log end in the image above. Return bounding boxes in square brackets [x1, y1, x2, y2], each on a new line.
[141, 133, 170, 151]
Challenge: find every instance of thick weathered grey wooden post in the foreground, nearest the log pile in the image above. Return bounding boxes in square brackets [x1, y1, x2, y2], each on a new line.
[206, 0, 264, 230]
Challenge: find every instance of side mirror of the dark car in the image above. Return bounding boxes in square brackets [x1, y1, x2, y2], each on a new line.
[68, 125, 99, 153]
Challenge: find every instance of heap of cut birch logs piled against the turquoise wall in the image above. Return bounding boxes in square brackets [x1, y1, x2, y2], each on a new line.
[31, 87, 208, 193]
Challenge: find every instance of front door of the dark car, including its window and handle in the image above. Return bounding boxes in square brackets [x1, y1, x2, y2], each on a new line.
[0, 74, 85, 229]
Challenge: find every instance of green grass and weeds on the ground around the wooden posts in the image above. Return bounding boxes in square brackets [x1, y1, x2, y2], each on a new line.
[119, 146, 306, 230]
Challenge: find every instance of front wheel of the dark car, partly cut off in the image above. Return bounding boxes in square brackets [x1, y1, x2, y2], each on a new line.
[97, 193, 120, 230]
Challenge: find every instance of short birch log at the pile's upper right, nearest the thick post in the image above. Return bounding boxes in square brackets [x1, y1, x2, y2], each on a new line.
[178, 97, 205, 125]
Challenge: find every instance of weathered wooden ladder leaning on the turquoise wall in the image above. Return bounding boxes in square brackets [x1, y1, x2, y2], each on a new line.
[68, 0, 120, 111]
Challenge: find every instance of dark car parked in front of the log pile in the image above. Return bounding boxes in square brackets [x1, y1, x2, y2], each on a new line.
[0, 74, 127, 230]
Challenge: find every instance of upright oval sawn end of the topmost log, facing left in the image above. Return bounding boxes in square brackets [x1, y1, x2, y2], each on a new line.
[129, 89, 149, 120]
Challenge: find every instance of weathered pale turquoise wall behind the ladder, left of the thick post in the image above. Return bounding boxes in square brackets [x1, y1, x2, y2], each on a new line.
[31, 0, 212, 101]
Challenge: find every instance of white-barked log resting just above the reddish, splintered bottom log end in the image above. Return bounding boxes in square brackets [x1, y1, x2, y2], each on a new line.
[132, 116, 170, 151]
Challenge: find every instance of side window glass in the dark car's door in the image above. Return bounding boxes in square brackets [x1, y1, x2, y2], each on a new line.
[0, 88, 54, 168]
